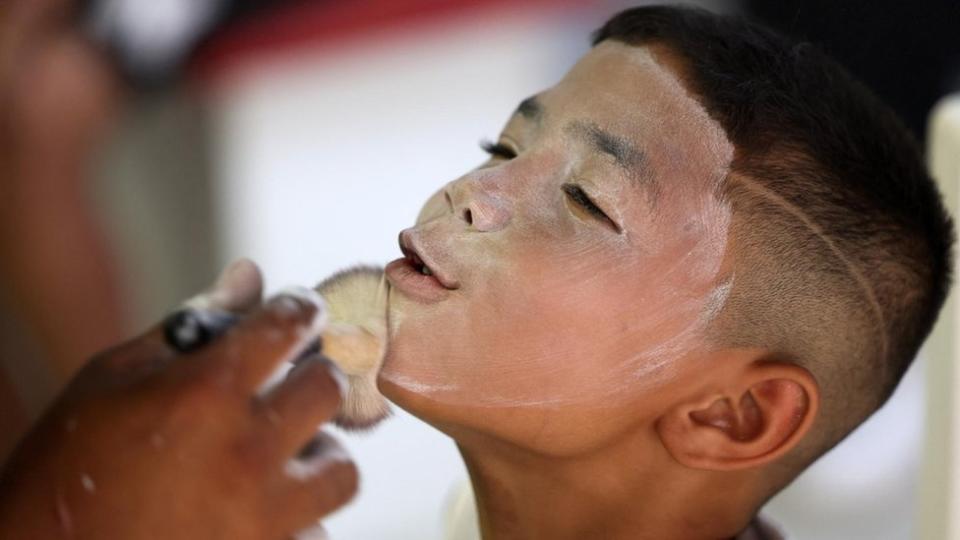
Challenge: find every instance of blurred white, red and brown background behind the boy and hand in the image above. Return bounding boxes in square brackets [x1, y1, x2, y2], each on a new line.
[0, 0, 960, 540]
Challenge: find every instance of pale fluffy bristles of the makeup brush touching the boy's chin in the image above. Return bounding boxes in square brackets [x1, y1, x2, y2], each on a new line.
[316, 266, 390, 430]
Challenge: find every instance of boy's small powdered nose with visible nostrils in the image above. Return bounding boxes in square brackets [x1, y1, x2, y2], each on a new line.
[444, 178, 513, 232]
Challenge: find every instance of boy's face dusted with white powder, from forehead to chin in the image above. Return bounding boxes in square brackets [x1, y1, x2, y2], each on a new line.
[380, 42, 733, 452]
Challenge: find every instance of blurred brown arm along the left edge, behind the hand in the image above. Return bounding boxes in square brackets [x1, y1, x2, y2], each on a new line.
[0, 0, 123, 449]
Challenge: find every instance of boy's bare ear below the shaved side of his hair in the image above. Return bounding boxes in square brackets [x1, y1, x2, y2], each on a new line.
[656, 351, 820, 470]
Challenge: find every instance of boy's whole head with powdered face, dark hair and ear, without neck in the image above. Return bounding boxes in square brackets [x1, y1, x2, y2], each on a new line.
[380, 7, 952, 506]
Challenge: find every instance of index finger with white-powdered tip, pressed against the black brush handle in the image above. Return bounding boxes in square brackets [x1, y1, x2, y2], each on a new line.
[198, 287, 327, 392]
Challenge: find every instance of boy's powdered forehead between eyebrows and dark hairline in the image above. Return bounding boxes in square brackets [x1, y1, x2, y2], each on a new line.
[538, 41, 733, 190]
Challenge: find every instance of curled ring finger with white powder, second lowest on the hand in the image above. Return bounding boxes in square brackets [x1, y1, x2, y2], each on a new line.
[277, 432, 359, 531]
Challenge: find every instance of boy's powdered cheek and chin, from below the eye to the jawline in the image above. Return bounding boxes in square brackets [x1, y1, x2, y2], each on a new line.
[382, 198, 722, 407]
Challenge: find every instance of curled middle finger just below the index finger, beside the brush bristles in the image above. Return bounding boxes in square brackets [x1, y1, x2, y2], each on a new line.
[262, 355, 347, 455]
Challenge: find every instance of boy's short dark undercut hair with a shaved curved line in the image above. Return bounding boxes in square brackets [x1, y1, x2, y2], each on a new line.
[593, 6, 954, 481]
